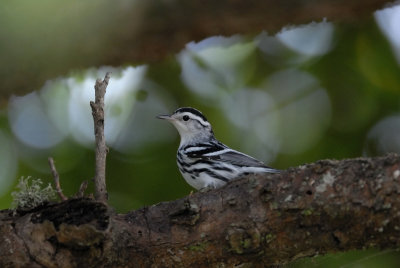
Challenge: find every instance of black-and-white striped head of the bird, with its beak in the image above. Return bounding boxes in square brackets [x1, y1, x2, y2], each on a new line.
[157, 107, 214, 145]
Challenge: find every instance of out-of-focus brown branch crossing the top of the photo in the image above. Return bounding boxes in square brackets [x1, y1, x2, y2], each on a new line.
[0, 0, 393, 98]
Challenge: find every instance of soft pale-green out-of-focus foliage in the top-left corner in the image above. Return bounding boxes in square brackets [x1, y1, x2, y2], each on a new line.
[0, 0, 142, 100]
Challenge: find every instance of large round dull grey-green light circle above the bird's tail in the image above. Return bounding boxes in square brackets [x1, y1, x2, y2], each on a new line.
[265, 69, 331, 154]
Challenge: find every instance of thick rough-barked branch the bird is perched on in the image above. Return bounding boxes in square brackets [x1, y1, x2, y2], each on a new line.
[0, 154, 400, 267]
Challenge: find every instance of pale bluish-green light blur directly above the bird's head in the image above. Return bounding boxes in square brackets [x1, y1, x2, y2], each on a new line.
[178, 36, 256, 101]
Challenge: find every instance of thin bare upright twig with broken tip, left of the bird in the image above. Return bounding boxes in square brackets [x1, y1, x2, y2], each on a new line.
[90, 73, 110, 202]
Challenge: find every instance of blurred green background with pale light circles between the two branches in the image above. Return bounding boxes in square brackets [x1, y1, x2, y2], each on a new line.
[0, 1, 400, 267]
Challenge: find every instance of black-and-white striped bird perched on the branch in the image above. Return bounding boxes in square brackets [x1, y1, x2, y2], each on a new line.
[157, 107, 280, 191]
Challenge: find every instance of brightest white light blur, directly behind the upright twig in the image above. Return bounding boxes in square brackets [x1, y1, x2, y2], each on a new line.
[68, 66, 146, 146]
